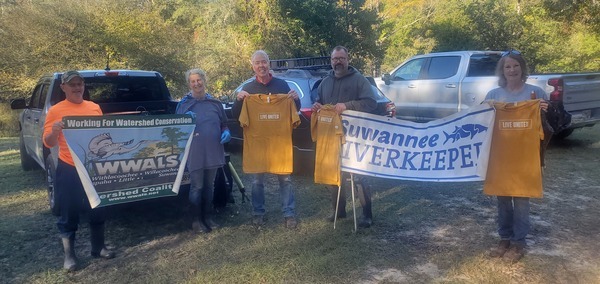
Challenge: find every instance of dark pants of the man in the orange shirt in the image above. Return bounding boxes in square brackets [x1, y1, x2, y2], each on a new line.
[54, 159, 106, 238]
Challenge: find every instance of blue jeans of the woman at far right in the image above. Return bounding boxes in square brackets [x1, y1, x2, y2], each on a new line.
[498, 196, 529, 246]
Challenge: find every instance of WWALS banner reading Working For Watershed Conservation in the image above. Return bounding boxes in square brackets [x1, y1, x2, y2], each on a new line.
[63, 115, 195, 208]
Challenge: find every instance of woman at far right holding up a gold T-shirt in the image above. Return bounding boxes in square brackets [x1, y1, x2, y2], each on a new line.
[483, 50, 548, 262]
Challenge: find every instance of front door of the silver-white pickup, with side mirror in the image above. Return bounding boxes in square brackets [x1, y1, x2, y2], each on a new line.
[379, 58, 426, 121]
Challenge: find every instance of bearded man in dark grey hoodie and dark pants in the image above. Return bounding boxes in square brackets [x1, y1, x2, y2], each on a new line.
[312, 46, 377, 228]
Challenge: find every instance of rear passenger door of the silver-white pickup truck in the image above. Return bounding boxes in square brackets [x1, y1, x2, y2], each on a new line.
[418, 55, 461, 121]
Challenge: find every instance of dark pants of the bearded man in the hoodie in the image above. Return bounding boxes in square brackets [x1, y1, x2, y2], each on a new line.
[328, 173, 373, 219]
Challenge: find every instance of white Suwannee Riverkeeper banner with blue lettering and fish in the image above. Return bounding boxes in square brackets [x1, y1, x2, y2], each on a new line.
[341, 104, 495, 182]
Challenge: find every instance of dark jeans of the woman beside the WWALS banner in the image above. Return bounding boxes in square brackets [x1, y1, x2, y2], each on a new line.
[189, 169, 217, 212]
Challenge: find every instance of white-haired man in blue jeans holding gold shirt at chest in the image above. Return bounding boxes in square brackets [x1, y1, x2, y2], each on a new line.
[232, 50, 300, 229]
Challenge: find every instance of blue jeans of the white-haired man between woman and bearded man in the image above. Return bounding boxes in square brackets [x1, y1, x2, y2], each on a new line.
[252, 173, 296, 217]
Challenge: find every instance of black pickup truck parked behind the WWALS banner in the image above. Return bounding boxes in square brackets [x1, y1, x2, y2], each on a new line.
[11, 70, 177, 214]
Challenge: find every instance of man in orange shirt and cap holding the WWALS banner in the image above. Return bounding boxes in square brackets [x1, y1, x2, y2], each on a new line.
[43, 71, 115, 271]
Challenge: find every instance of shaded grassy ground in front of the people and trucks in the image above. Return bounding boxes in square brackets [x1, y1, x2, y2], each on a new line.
[0, 126, 600, 283]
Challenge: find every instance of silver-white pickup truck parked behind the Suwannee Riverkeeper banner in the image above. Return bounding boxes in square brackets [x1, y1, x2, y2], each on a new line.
[376, 51, 600, 138]
